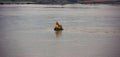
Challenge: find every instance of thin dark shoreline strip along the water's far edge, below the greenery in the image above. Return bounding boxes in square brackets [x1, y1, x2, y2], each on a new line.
[0, 1, 120, 5]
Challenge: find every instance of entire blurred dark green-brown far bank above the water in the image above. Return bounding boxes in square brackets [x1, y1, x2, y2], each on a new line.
[0, 0, 120, 4]
